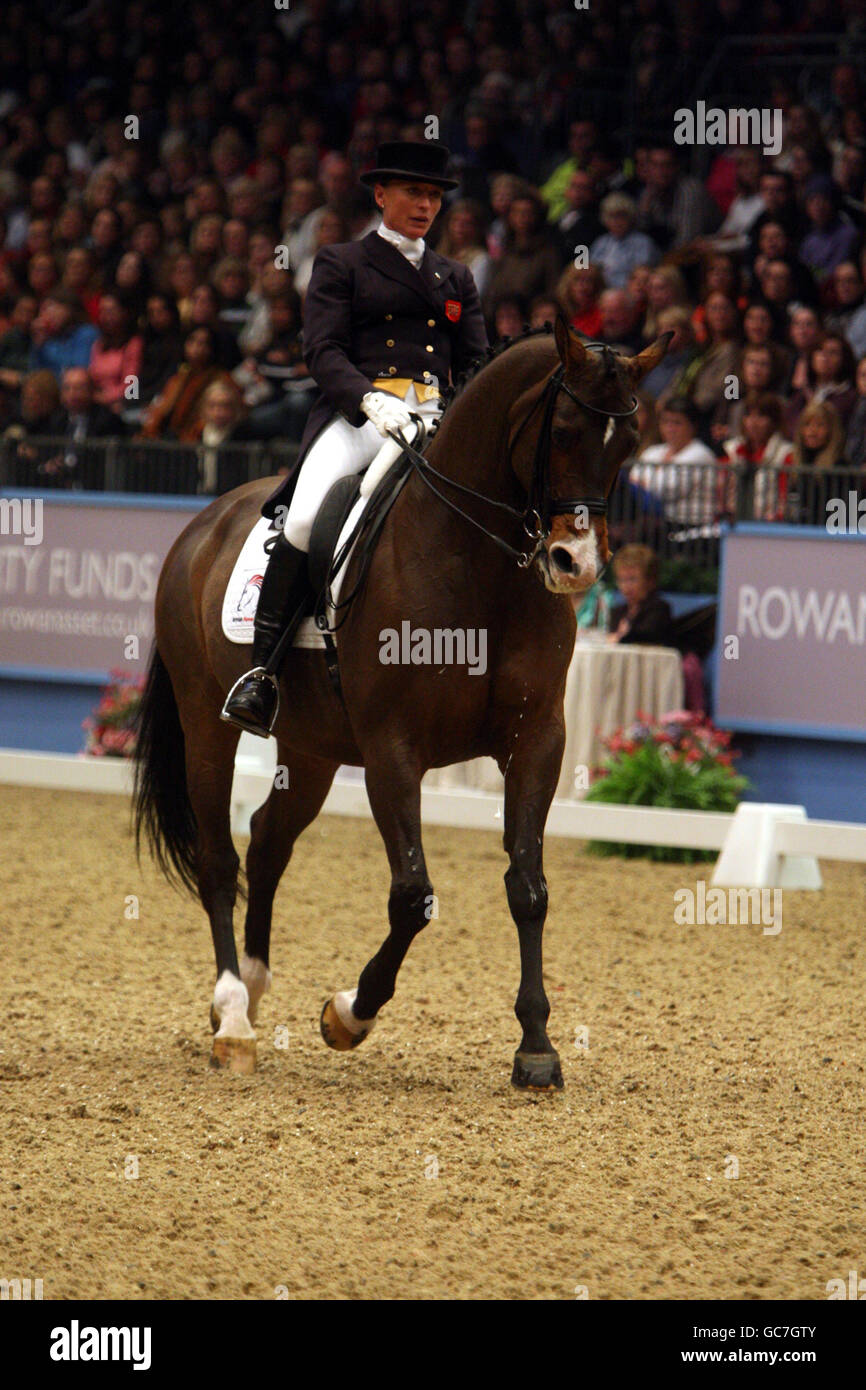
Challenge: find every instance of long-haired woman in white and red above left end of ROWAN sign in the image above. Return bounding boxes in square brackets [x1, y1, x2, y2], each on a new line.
[720, 391, 794, 521]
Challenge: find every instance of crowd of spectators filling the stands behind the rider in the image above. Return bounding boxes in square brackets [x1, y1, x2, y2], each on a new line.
[0, 0, 866, 524]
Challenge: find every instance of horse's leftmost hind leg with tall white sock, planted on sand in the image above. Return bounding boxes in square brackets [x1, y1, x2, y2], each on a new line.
[179, 682, 256, 1073]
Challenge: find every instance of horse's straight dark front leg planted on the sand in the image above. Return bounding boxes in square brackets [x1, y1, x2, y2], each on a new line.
[503, 723, 566, 1091]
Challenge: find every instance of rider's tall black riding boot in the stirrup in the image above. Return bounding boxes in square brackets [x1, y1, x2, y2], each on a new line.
[221, 531, 307, 738]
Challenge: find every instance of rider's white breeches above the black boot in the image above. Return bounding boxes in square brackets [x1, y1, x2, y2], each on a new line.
[284, 386, 442, 550]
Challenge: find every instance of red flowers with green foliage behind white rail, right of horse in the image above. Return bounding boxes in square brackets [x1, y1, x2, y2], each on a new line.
[587, 709, 749, 863]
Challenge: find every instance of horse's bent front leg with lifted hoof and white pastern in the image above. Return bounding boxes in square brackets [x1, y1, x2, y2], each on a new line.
[321, 751, 432, 1051]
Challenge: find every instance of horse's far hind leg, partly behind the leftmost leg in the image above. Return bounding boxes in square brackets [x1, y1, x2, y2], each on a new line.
[240, 744, 339, 1023]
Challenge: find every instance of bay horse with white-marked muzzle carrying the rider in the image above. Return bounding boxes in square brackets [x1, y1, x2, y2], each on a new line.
[133, 317, 671, 1090]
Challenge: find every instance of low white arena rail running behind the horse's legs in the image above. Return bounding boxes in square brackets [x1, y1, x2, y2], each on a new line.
[0, 735, 866, 888]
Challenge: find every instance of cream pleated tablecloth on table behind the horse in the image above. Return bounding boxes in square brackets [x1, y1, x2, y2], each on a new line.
[424, 641, 683, 801]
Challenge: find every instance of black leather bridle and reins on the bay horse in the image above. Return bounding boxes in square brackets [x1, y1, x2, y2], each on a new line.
[388, 343, 638, 570]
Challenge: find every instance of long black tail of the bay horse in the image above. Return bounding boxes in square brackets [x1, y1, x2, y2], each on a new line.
[132, 644, 199, 892]
